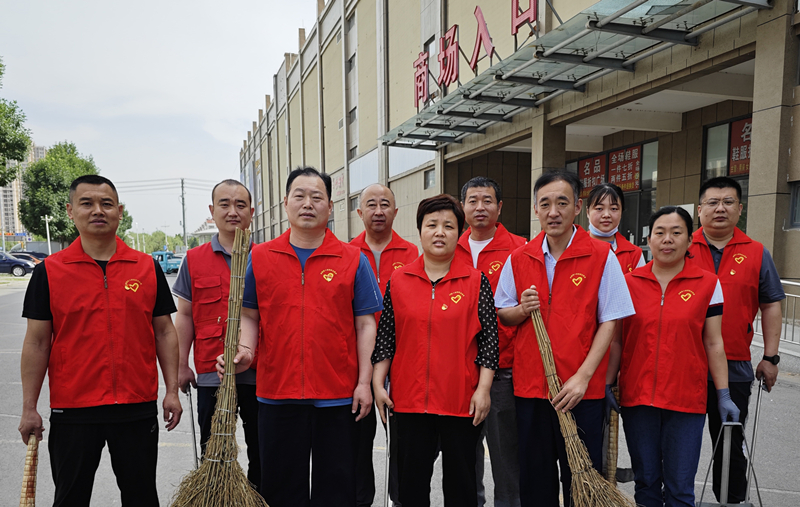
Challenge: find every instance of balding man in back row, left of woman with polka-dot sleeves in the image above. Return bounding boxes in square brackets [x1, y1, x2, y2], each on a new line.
[350, 183, 419, 507]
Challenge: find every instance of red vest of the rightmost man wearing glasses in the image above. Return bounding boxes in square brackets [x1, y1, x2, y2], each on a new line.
[689, 227, 764, 361]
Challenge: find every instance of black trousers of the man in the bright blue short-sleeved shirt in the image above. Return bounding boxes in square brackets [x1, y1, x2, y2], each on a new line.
[258, 403, 358, 507]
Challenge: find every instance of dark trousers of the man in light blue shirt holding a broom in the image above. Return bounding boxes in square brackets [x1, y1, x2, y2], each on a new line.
[516, 397, 604, 507]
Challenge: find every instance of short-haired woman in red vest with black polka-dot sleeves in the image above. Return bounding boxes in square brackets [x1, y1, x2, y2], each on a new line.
[372, 194, 500, 507]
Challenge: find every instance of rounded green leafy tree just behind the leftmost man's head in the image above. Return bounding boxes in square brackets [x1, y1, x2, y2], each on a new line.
[19, 141, 99, 246]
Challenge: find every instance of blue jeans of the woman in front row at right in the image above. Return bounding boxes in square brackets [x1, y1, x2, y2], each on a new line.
[622, 406, 705, 507]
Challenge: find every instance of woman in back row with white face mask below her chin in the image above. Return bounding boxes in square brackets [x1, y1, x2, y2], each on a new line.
[586, 183, 645, 273]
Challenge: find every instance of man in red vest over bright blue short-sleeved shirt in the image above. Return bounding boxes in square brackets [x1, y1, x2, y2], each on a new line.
[217, 167, 383, 507]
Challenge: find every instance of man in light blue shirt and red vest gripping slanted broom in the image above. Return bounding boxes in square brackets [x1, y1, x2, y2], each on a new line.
[495, 171, 634, 507]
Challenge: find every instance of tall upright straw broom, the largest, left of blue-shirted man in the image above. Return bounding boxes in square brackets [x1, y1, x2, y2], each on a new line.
[172, 229, 268, 507]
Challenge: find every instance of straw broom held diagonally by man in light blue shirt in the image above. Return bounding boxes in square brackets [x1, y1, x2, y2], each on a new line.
[531, 310, 636, 507]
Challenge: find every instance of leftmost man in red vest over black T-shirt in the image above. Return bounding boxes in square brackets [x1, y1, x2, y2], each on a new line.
[19, 175, 181, 507]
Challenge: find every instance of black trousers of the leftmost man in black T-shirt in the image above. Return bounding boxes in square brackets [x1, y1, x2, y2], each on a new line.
[47, 416, 158, 507]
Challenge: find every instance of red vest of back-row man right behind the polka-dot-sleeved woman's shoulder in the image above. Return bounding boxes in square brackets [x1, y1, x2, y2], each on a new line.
[455, 223, 525, 368]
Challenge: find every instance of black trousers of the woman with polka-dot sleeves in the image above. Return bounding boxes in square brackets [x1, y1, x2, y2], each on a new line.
[391, 412, 483, 507]
